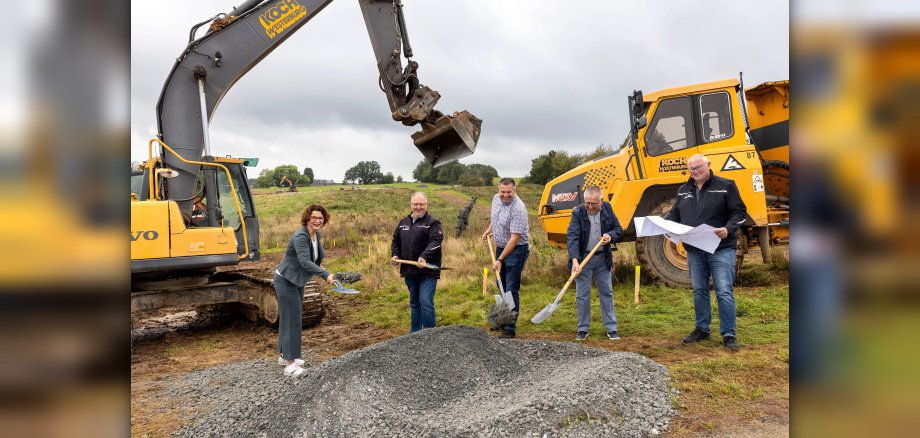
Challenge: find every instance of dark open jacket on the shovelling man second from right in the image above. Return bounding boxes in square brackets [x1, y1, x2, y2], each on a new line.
[566, 201, 623, 270]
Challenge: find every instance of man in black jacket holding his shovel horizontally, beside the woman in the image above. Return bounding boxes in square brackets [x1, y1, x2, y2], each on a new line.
[390, 192, 444, 332]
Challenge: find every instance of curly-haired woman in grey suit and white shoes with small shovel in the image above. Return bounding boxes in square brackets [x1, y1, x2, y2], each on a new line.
[275, 205, 334, 377]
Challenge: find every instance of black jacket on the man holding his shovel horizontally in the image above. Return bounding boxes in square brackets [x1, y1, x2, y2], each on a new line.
[390, 213, 444, 278]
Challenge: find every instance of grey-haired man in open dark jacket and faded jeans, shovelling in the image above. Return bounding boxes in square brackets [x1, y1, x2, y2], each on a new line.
[566, 186, 623, 341]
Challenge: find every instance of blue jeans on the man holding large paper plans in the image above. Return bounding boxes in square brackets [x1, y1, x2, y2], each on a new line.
[687, 248, 735, 337]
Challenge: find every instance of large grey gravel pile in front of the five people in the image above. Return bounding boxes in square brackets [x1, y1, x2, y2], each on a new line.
[172, 326, 674, 437]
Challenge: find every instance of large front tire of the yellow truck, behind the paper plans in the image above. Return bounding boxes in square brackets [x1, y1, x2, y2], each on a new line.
[636, 201, 747, 289]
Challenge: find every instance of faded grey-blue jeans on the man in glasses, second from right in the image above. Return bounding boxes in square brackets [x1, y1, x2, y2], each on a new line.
[575, 257, 617, 332]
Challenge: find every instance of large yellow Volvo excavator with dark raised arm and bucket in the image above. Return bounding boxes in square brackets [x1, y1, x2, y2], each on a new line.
[130, 0, 482, 326]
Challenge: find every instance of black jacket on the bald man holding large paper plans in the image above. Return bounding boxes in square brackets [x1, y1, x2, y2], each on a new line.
[664, 170, 747, 250]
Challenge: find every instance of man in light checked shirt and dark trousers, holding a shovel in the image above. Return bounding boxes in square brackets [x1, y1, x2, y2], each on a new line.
[482, 178, 530, 339]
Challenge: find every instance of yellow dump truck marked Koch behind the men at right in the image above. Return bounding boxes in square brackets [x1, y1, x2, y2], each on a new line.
[539, 79, 789, 287]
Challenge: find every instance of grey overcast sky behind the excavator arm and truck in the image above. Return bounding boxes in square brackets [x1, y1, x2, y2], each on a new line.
[131, 0, 789, 181]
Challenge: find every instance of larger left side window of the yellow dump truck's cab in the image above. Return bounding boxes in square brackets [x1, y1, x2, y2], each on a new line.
[645, 97, 696, 156]
